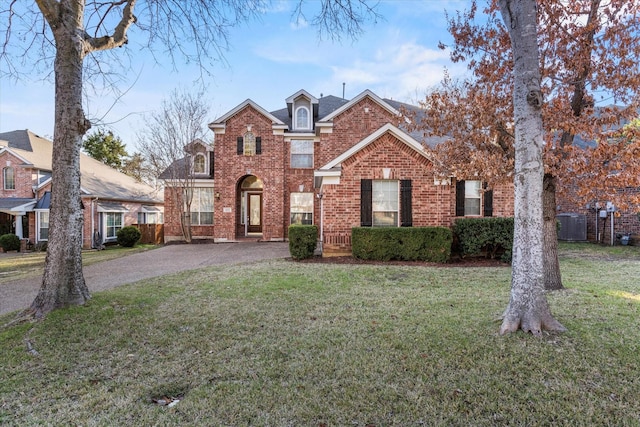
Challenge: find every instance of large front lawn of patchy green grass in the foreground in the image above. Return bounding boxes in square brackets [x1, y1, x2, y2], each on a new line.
[0, 245, 640, 426]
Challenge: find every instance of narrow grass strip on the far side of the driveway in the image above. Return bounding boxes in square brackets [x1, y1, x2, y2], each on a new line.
[0, 245, 158, 285]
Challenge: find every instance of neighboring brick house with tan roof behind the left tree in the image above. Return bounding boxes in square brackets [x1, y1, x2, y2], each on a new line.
[0, 130, 164, 248]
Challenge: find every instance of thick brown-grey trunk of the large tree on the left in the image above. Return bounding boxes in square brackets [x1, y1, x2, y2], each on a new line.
[28, 1, 91, 317]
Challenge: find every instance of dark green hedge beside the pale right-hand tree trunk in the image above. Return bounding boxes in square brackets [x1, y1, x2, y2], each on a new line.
[453, 218, 513, 262]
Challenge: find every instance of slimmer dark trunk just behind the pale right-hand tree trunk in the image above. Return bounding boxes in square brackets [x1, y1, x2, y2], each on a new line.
[542, 174, 563, 291]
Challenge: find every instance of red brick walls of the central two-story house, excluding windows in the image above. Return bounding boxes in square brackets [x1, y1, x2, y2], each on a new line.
[165, 91, 513, 254]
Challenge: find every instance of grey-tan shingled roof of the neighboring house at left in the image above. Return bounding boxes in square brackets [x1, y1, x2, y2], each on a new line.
[0, 130, 164, 203]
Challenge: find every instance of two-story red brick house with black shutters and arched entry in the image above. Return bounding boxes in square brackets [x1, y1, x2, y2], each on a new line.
[161, 90, 513, 255]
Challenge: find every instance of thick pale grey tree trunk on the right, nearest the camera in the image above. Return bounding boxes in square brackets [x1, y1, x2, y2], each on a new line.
[499, 0, 564, 335]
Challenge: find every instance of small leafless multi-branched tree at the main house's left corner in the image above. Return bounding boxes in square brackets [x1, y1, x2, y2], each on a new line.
[138, 89, 209, 242]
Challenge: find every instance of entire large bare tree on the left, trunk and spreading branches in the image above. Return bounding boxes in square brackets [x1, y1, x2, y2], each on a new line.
[0, 0, 372, 317]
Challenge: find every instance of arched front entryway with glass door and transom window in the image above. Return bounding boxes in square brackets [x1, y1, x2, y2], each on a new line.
[236, 175, 262, 237]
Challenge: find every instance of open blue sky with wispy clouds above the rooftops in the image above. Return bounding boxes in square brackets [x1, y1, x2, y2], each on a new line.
[0, 0, 469, 152]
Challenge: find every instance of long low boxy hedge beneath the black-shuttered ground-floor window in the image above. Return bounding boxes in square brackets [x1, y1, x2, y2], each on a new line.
[351, 227, 453, 263]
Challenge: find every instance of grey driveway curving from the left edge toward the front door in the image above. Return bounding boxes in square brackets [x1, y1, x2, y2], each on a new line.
[0, 242, 290, 314]
